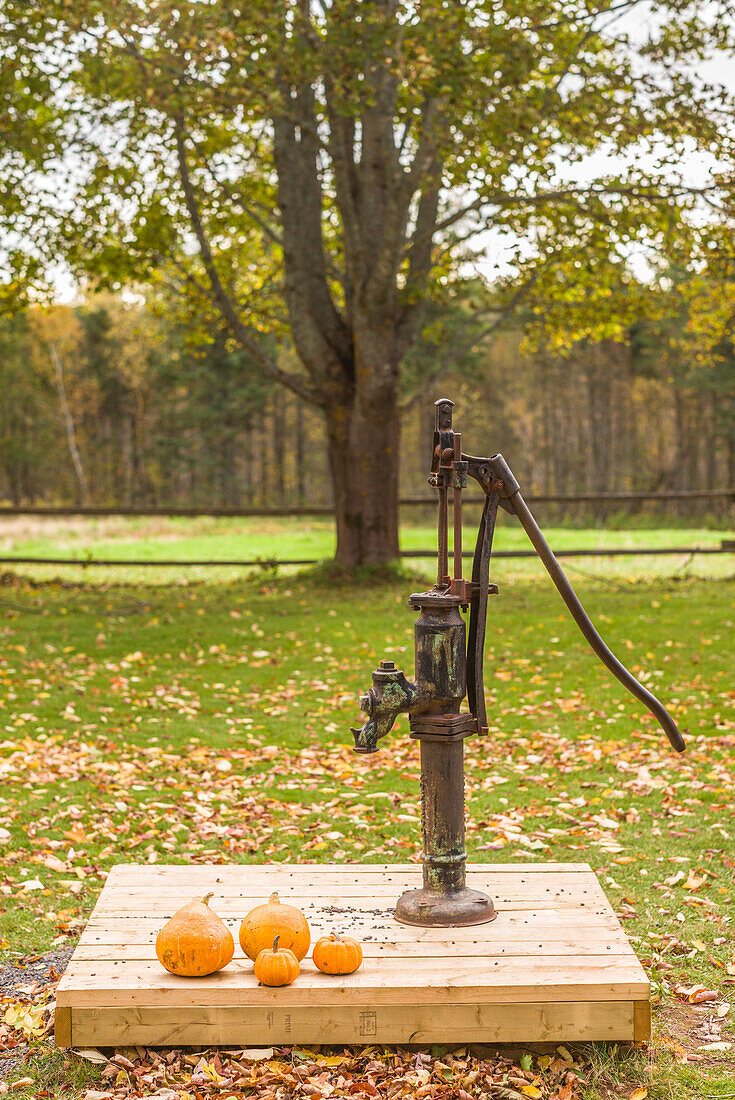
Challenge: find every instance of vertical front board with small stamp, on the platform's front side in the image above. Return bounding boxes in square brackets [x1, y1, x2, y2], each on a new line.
[66, 1001, 637, 1047]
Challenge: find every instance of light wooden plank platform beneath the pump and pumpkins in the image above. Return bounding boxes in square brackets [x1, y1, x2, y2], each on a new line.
[56, 864, 650, 1047]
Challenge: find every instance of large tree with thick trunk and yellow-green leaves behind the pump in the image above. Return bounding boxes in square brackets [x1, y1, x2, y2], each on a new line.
[0, 0, 732, 564]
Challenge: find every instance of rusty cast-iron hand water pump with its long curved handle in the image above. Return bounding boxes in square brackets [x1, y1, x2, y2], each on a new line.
[352, 398, 684, 926]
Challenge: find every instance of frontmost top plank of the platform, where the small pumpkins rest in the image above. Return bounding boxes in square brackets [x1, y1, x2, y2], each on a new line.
[57, 955, 649, 1007]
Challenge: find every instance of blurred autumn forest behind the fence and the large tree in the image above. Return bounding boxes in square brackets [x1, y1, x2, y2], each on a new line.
[0, 294, 735, 516]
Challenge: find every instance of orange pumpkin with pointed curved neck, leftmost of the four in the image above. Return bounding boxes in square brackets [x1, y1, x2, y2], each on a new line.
[155, 893, 234, 978]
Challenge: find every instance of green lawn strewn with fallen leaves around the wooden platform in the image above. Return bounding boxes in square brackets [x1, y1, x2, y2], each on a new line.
[0, 569, 735, 1100]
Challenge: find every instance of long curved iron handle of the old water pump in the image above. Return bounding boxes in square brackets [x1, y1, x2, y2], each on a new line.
[462, 454, 687, 752]
